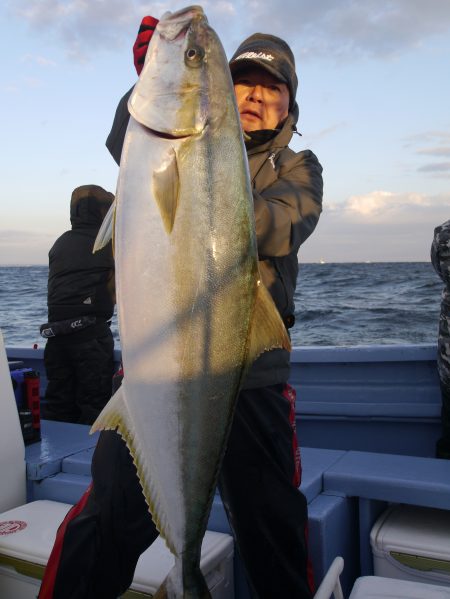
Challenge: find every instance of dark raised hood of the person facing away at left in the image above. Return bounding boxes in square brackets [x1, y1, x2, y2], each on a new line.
[70, 185, 114, 229]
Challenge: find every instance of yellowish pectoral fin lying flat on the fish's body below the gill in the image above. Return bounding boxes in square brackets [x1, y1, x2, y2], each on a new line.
[152, 148, 180, 233]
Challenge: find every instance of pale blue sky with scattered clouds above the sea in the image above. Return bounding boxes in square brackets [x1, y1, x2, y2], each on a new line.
[0, 0, 450, 265]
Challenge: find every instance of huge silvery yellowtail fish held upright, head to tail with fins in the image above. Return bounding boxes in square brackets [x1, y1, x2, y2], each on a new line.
[93, 6, 289, 599]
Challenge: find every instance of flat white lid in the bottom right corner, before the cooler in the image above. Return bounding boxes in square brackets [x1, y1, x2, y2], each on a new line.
[348, 576, 450, 599]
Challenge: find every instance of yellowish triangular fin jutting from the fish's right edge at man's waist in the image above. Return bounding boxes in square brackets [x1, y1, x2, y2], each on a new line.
[248, 281, 291, 362]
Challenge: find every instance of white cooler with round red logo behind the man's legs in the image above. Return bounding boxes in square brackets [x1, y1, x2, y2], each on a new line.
[0, 500, 234, 599]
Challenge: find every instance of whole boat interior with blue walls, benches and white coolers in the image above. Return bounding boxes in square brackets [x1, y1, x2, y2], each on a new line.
[0, 336, 450, 599]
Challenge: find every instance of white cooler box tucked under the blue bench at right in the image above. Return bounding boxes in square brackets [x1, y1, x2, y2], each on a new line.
[370, 504, 450, 587]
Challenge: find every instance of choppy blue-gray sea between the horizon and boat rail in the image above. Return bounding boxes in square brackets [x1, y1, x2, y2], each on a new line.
[0, 262, 443, 347]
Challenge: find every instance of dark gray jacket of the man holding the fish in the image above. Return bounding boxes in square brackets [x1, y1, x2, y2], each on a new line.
[106, 89, 323, 389]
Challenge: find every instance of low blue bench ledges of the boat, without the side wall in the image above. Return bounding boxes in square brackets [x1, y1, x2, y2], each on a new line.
[26, 420, 450, 599]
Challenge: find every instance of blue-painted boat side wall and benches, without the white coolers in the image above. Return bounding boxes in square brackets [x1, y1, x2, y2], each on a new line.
[3, 345, 450, 599]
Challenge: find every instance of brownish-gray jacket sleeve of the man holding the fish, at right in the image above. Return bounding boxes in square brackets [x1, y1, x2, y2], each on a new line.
[253, 150, 323, 257]
